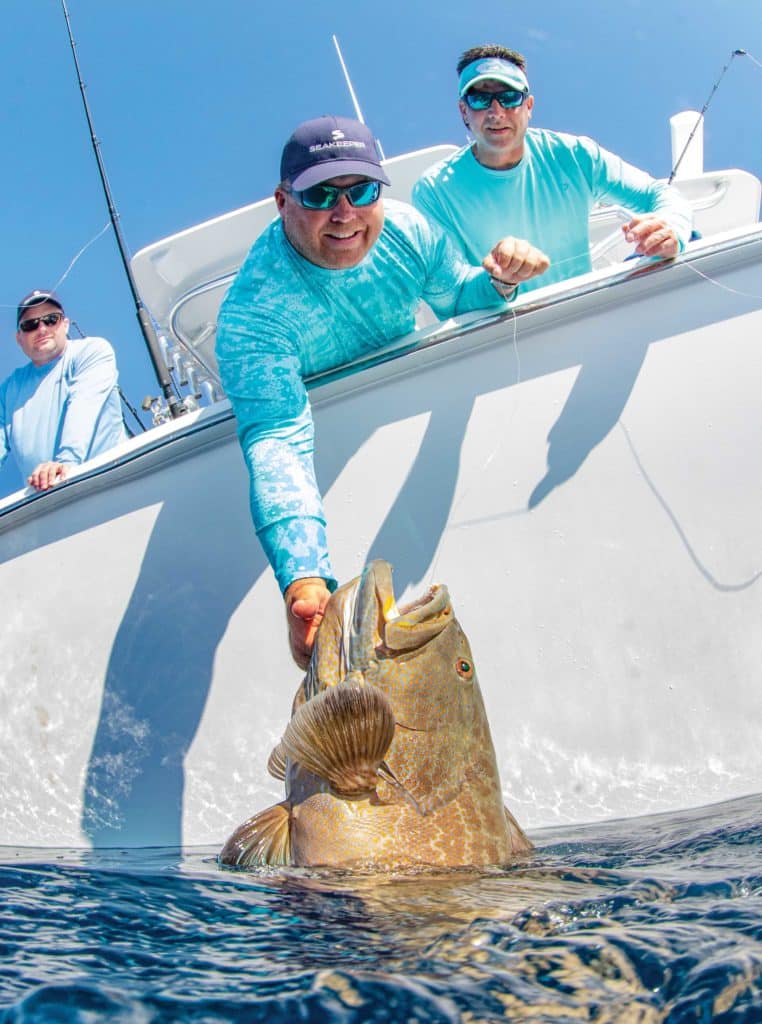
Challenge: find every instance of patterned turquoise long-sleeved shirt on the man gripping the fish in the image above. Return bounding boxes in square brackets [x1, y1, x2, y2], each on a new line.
[216, 200, 505, 591]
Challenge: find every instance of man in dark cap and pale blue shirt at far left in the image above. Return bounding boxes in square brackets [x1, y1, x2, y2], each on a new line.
[0, 289, 127, 490]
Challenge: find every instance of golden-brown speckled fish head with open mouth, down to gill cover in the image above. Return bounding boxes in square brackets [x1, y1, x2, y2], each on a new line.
[313, 560, 492, 810]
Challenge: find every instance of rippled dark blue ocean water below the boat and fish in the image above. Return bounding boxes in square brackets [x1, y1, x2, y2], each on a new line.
[0, 796, 762, 1024]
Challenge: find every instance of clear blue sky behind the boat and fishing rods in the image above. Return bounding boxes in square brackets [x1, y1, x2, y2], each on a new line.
[0, 0, 762, 495]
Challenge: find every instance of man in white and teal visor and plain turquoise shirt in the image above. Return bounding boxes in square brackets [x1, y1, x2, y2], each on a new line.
[413, 46, 691, 292]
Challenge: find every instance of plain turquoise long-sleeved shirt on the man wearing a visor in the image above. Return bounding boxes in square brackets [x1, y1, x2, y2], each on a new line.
[413, 128, 691, 292]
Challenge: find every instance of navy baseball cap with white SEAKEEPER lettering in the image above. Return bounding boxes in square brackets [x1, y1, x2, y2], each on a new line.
[281, 117, 390, 191]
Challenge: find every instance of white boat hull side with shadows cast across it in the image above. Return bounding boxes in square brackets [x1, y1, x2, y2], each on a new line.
[0, 232, 762, 847]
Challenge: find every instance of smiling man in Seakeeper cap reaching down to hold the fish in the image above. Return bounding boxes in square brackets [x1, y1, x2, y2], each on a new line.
[216, 117, 548, 667]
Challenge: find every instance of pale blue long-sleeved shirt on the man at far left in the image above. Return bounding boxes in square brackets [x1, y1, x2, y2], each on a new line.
[0, 338, 127, 481]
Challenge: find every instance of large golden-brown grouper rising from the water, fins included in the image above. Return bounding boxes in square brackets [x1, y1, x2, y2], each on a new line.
[220, 560, 532, 868]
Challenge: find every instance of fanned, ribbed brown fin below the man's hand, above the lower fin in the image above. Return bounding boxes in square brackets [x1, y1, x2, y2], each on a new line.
[281, 681, 394, 796]
